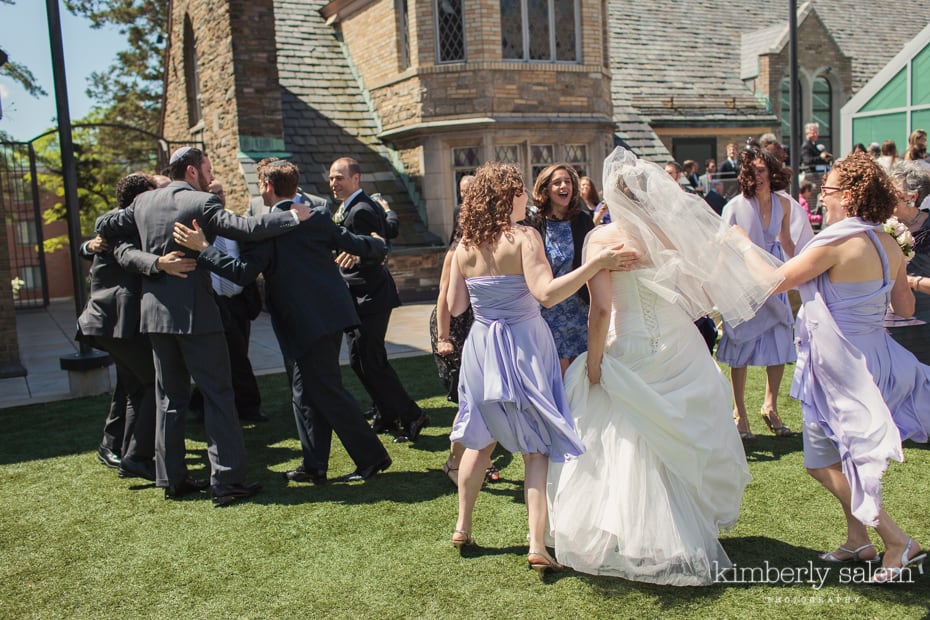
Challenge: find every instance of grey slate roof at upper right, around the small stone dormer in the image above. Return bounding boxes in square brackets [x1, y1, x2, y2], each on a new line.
[609, 0, 930, 161]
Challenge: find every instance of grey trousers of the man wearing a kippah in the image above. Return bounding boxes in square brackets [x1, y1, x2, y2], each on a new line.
[149, 332, 246, 487]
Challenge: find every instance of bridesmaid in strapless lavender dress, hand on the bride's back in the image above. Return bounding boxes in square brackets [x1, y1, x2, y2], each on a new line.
[449, 162, 636, 572]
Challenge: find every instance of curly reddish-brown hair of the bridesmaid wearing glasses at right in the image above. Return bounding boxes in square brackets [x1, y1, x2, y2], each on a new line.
[833, 153, 899, 224]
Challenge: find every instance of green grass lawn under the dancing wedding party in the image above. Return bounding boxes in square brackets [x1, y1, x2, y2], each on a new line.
[0, 357, 930, 618]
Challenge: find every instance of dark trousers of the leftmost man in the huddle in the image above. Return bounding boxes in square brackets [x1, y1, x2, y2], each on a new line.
[82, 334, 155, 461]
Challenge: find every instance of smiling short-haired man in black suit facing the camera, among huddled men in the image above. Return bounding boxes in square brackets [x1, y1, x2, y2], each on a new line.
[329, 157, 430, 442]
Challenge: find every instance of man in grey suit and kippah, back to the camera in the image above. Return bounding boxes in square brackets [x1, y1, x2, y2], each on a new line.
[97, 147, 310, 506]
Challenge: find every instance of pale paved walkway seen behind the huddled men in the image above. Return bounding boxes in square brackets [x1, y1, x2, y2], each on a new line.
[0, 299, 433, 409]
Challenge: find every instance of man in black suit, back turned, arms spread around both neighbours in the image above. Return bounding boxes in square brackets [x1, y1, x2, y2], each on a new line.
[175, 161, 391, 483]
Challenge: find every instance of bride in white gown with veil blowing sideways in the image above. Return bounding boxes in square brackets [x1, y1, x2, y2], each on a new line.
[550, 148, 779, 585]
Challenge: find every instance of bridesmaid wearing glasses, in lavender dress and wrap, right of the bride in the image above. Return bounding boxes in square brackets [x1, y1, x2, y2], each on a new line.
[764, 153, 930, 583]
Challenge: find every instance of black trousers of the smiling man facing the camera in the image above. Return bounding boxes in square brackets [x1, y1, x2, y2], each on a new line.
[346, 310, 422, 428]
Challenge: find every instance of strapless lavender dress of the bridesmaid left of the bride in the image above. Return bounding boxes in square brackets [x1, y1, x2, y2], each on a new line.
[449, 275, 584, 462]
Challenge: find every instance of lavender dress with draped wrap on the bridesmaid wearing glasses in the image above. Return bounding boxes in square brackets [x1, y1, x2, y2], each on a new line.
[791, 218, 930, 525]
